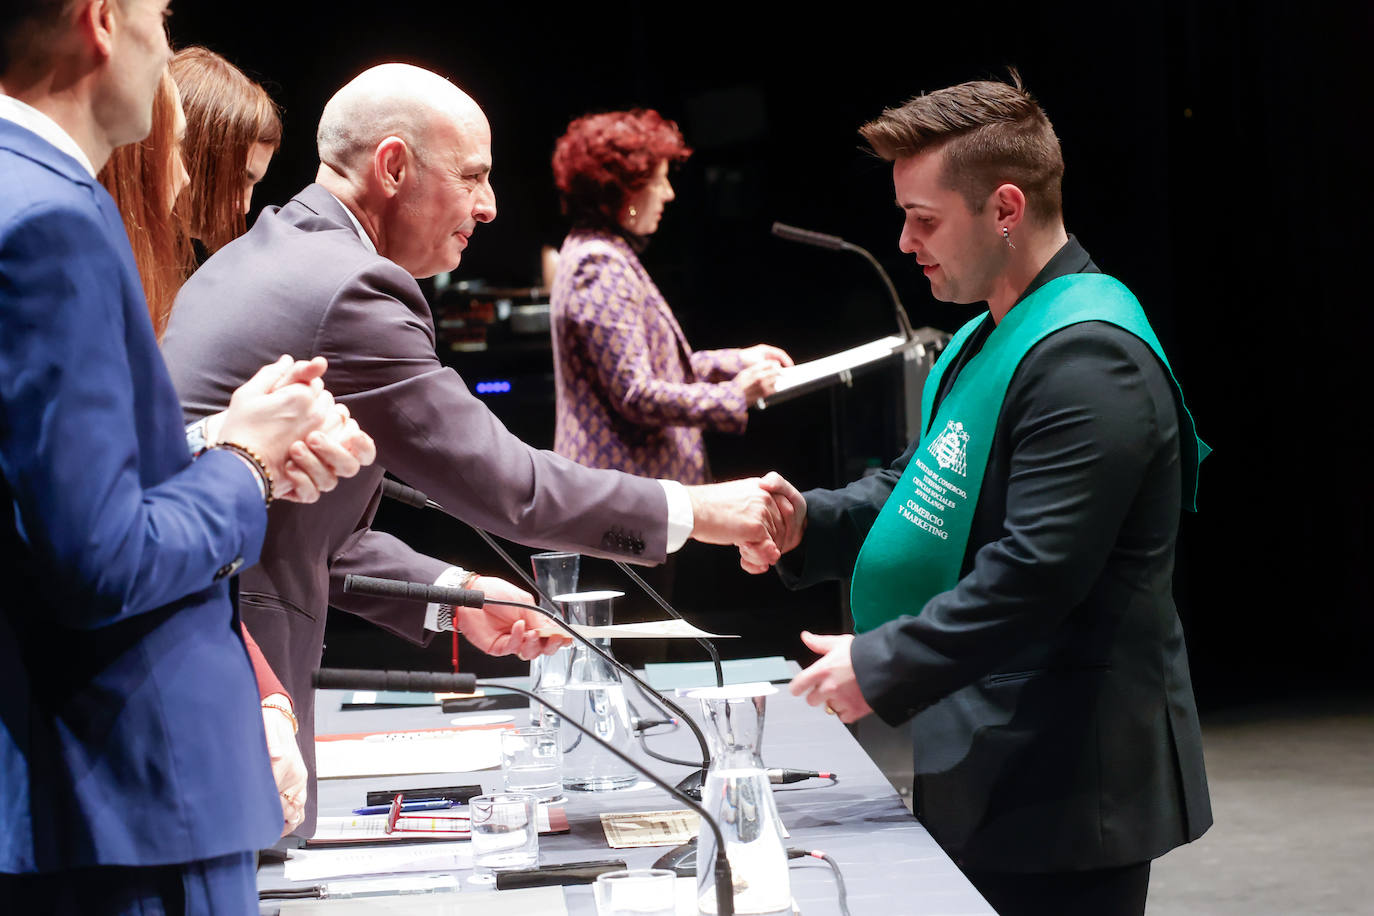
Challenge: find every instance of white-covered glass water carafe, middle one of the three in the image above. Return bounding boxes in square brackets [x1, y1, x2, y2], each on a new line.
[554, 592, 639, 792]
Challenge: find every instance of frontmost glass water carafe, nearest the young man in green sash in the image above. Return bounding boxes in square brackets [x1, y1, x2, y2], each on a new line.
[687, 684, 791, 916]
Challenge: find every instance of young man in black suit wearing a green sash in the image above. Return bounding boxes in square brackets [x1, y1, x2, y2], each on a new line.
[742, 78, 1212, 916]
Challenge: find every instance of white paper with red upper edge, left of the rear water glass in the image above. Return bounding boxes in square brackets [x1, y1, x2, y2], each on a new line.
[315, 728, 503, 779]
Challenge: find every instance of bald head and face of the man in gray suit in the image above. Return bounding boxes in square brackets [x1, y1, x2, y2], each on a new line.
[316, 63, 496, 277]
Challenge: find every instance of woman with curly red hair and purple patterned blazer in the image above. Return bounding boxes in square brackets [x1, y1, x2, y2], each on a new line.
[551, 110, 791, 485]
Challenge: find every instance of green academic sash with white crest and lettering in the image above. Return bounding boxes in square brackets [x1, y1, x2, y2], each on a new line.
[849, 273, 1210, 633]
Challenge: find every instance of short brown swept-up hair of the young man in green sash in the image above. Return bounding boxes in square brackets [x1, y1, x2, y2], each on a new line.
[859, 70, 1063, 222]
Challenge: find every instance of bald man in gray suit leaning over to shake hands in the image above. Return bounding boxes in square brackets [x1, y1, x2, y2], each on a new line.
[164, 65, 791, 835]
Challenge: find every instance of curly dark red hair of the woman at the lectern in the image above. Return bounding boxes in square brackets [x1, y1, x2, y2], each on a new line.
[554, 108, 691, 228]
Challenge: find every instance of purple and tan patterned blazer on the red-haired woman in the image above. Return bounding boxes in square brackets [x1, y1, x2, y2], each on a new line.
[550, 229, 749, 485]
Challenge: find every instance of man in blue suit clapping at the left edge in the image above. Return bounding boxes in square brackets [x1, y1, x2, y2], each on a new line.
[0, 0, 371, 913]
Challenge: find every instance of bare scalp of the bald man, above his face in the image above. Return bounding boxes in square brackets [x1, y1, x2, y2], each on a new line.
[316, 63, 488, 176]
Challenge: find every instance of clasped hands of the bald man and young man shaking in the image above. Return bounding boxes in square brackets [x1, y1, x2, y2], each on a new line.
[687, 471, 807, 574]
